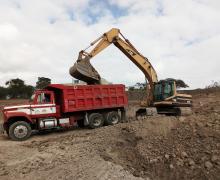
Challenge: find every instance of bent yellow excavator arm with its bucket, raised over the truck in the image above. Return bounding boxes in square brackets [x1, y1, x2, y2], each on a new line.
[70, 28, 158, 100]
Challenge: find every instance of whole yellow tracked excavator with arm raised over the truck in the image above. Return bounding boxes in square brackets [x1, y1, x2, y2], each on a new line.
[70, 28, 192, 116]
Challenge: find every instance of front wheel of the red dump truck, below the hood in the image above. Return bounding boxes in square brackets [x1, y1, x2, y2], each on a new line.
[8, 121, 31, 141]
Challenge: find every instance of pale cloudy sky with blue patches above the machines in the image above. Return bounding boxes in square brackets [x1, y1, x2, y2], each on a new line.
[0, 0, 220, 89]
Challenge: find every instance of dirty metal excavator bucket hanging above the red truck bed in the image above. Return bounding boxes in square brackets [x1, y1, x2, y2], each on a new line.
[69, 55, 101, 84]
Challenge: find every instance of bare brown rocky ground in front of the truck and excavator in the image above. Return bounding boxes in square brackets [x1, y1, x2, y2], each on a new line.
[0, 91, 220, 180]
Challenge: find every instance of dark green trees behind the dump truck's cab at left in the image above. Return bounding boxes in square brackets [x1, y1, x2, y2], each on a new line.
[0, 77, 51, 99]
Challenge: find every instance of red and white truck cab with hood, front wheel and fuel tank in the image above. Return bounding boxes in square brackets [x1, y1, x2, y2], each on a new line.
[3, 90, 60, 140]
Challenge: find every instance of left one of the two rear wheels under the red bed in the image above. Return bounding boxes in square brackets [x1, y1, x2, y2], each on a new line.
[89, 113, 104, 129]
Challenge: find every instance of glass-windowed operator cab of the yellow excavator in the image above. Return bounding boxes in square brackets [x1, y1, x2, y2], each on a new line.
[153, 80, 176, 102]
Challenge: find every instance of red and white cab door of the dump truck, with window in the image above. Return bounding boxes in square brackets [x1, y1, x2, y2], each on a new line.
[31, 92, 56, 117]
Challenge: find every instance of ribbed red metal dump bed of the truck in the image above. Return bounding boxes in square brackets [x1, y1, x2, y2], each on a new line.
[47, 84, 128, 113]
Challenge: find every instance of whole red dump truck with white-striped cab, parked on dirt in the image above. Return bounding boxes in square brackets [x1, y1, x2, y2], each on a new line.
[2, 84, 128, 141]
